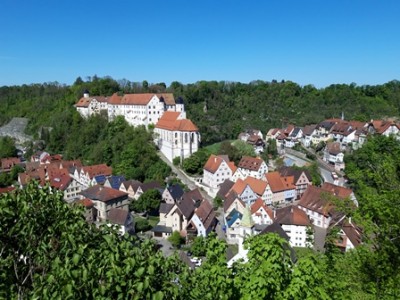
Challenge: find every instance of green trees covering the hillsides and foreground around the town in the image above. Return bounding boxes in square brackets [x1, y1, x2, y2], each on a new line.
[0, 77, 400, 299]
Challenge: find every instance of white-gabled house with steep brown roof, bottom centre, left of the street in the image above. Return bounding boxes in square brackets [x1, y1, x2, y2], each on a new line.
[187, 199, 217, 237]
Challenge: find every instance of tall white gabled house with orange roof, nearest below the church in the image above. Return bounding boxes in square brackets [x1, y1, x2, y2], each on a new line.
[202, 154, 237, 192]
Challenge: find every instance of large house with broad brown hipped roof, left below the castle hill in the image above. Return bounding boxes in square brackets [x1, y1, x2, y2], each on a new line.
[80, 185, 129, 222]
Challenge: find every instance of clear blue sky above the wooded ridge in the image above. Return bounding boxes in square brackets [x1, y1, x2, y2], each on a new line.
[0, 0, 400, 87]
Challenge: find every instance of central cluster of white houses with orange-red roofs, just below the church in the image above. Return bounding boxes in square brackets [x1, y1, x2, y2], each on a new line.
[202, 154, 312, 205]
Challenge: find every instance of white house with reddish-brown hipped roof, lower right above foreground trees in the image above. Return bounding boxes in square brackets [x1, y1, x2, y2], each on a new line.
[274, 206, 314, 247]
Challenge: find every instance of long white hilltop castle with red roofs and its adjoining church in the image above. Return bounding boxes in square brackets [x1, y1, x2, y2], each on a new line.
[75, 91, 201, 161]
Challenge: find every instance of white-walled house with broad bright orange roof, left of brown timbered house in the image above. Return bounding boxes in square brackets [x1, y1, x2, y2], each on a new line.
[265, 171, 296, 205]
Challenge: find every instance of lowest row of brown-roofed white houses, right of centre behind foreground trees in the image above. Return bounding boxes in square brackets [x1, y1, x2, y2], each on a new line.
[220, 177, 362, 251]
